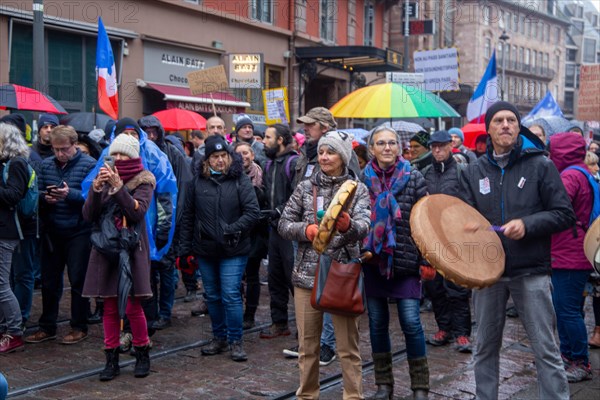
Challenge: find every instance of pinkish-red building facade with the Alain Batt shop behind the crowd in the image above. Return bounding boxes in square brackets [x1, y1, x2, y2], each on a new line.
[0, 0, 404, 128]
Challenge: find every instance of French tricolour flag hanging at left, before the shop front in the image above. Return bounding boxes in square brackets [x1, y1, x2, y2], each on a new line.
[96, 18, 119, 119]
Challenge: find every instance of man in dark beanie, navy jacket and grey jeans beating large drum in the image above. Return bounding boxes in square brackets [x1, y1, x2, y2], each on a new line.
[461, 101, 575, 400]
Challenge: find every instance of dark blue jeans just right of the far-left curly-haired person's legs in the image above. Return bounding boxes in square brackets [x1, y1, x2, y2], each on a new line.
[10, 236, 38, 321]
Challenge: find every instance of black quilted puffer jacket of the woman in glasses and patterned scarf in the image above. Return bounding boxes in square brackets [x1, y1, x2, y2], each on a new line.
[362, 167, 427, 277]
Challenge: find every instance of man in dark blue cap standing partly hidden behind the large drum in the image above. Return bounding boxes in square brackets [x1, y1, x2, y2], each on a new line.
[425, 131, 471, 353]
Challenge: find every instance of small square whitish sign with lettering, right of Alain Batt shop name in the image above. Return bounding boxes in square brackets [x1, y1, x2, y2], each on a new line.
[229, 53, 264, 89]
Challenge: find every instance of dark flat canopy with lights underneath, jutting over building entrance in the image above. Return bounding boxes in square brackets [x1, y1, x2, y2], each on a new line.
[296, 46, 403, 72]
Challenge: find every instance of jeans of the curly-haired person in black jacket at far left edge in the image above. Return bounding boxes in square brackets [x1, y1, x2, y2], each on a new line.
[0, 239, 23, 336]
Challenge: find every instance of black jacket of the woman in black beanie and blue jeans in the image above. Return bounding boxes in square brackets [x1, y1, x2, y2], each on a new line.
[179, 153, 260, 258]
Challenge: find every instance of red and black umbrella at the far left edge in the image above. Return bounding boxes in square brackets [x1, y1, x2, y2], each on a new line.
[0, 83, 67, 114]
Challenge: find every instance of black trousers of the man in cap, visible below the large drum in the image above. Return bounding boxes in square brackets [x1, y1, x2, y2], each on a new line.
[425, 273, 471, 337]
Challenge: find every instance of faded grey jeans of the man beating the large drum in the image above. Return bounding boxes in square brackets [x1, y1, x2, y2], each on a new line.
[473, 275, 569, 400]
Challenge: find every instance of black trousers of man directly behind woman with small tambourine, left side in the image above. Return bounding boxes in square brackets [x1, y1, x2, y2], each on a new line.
[268, 229, 294, 324]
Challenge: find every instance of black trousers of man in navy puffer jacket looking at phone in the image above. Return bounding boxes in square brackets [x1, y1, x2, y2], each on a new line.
[39, 232, 92, 335]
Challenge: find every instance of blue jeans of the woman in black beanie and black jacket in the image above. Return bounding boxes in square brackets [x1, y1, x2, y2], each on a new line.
[199, 257, 248, 343]
